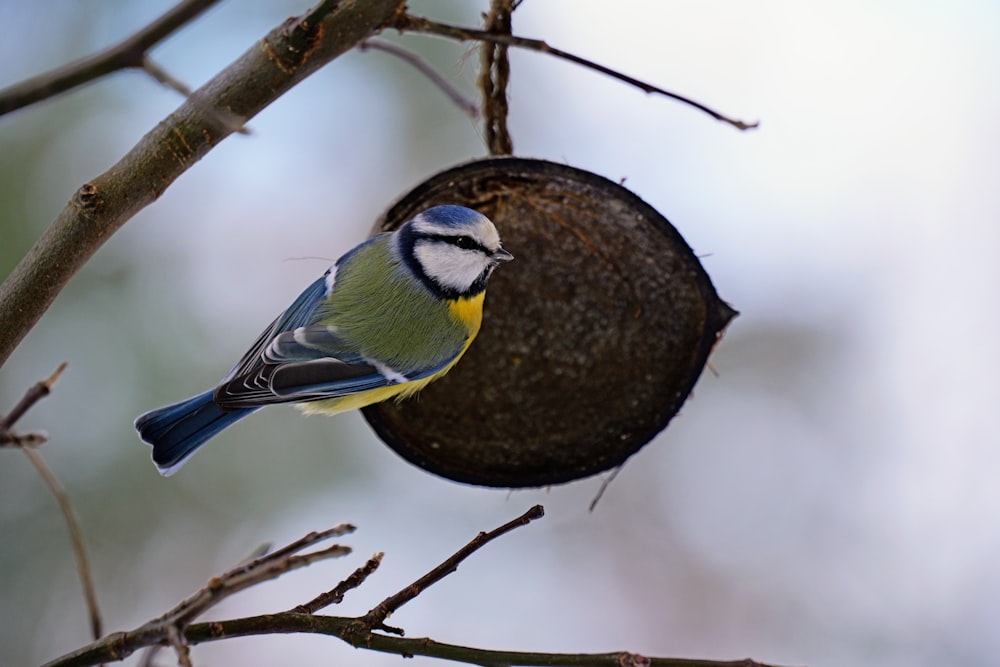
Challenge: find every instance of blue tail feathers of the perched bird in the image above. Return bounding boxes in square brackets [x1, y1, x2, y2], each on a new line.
[135, 390, 256, 476]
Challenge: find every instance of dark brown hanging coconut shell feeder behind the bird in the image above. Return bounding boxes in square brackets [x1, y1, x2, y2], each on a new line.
[364, 157, 736, 487]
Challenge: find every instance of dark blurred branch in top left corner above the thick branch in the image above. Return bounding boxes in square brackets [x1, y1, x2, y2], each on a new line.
[0, 0, 219, 115]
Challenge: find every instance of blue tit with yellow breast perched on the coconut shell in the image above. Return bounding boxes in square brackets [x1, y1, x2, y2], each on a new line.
[135, 205, 513, 476]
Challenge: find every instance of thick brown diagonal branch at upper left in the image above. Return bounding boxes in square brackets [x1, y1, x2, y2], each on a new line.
[0, 0, 404, 366]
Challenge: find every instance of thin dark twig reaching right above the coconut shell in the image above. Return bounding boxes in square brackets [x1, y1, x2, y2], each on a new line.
[393, 14, 760, 130]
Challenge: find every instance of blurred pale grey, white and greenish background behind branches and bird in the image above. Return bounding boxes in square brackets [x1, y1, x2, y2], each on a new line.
[0, 0, 1000, 667]
